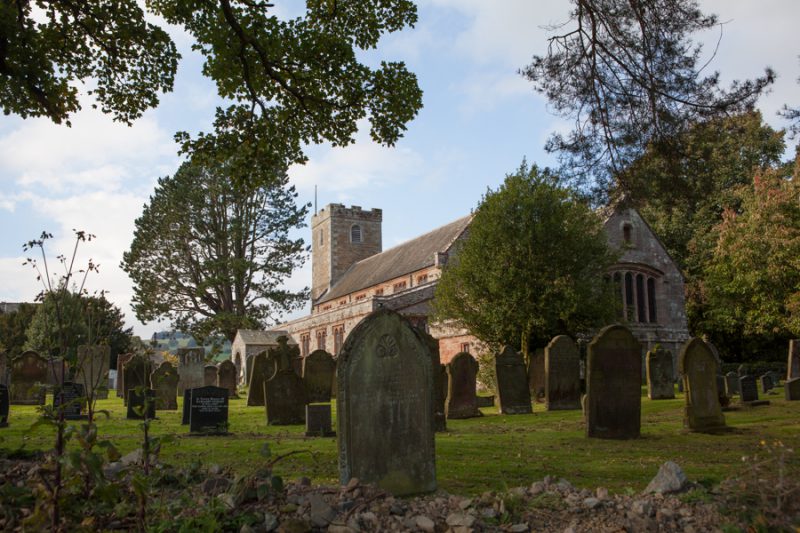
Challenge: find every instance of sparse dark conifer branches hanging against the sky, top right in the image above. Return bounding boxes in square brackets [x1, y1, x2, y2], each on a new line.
[522, 0, 774, 192]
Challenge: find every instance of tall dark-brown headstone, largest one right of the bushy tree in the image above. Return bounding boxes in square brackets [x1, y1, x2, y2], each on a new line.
[585, 325, 642, 439]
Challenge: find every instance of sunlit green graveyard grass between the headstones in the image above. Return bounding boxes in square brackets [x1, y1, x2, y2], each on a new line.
[0, 388, 800, 496]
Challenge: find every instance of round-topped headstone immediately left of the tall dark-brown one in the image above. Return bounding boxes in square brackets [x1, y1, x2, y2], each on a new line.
[544, 335, 581, 411]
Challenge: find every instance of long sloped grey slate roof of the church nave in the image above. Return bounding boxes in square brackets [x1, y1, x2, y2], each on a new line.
[315, 215, 472, 304]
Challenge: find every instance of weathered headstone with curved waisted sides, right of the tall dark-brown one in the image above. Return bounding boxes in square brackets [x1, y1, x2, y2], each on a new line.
[678, 337, 726, 431]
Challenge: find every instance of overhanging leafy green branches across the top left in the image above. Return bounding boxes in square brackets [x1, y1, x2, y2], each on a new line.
[0, 0, 422, 167]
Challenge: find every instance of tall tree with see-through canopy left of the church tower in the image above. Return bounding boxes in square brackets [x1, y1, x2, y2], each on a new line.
[121, 156, 308, 341]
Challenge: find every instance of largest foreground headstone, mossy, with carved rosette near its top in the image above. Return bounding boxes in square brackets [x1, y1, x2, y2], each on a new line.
[336, 309, 436, 496]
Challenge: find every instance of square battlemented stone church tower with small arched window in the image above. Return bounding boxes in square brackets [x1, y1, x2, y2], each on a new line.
[311, 204, 383, 303]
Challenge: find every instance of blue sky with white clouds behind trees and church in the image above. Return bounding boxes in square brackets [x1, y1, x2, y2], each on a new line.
[0, 0, 800, 338]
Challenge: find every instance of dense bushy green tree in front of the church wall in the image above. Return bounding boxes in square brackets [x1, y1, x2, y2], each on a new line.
[434, 162, 617, 355]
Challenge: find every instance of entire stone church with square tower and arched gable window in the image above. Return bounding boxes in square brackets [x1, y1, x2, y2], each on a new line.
[279, 204, 689, 363]
